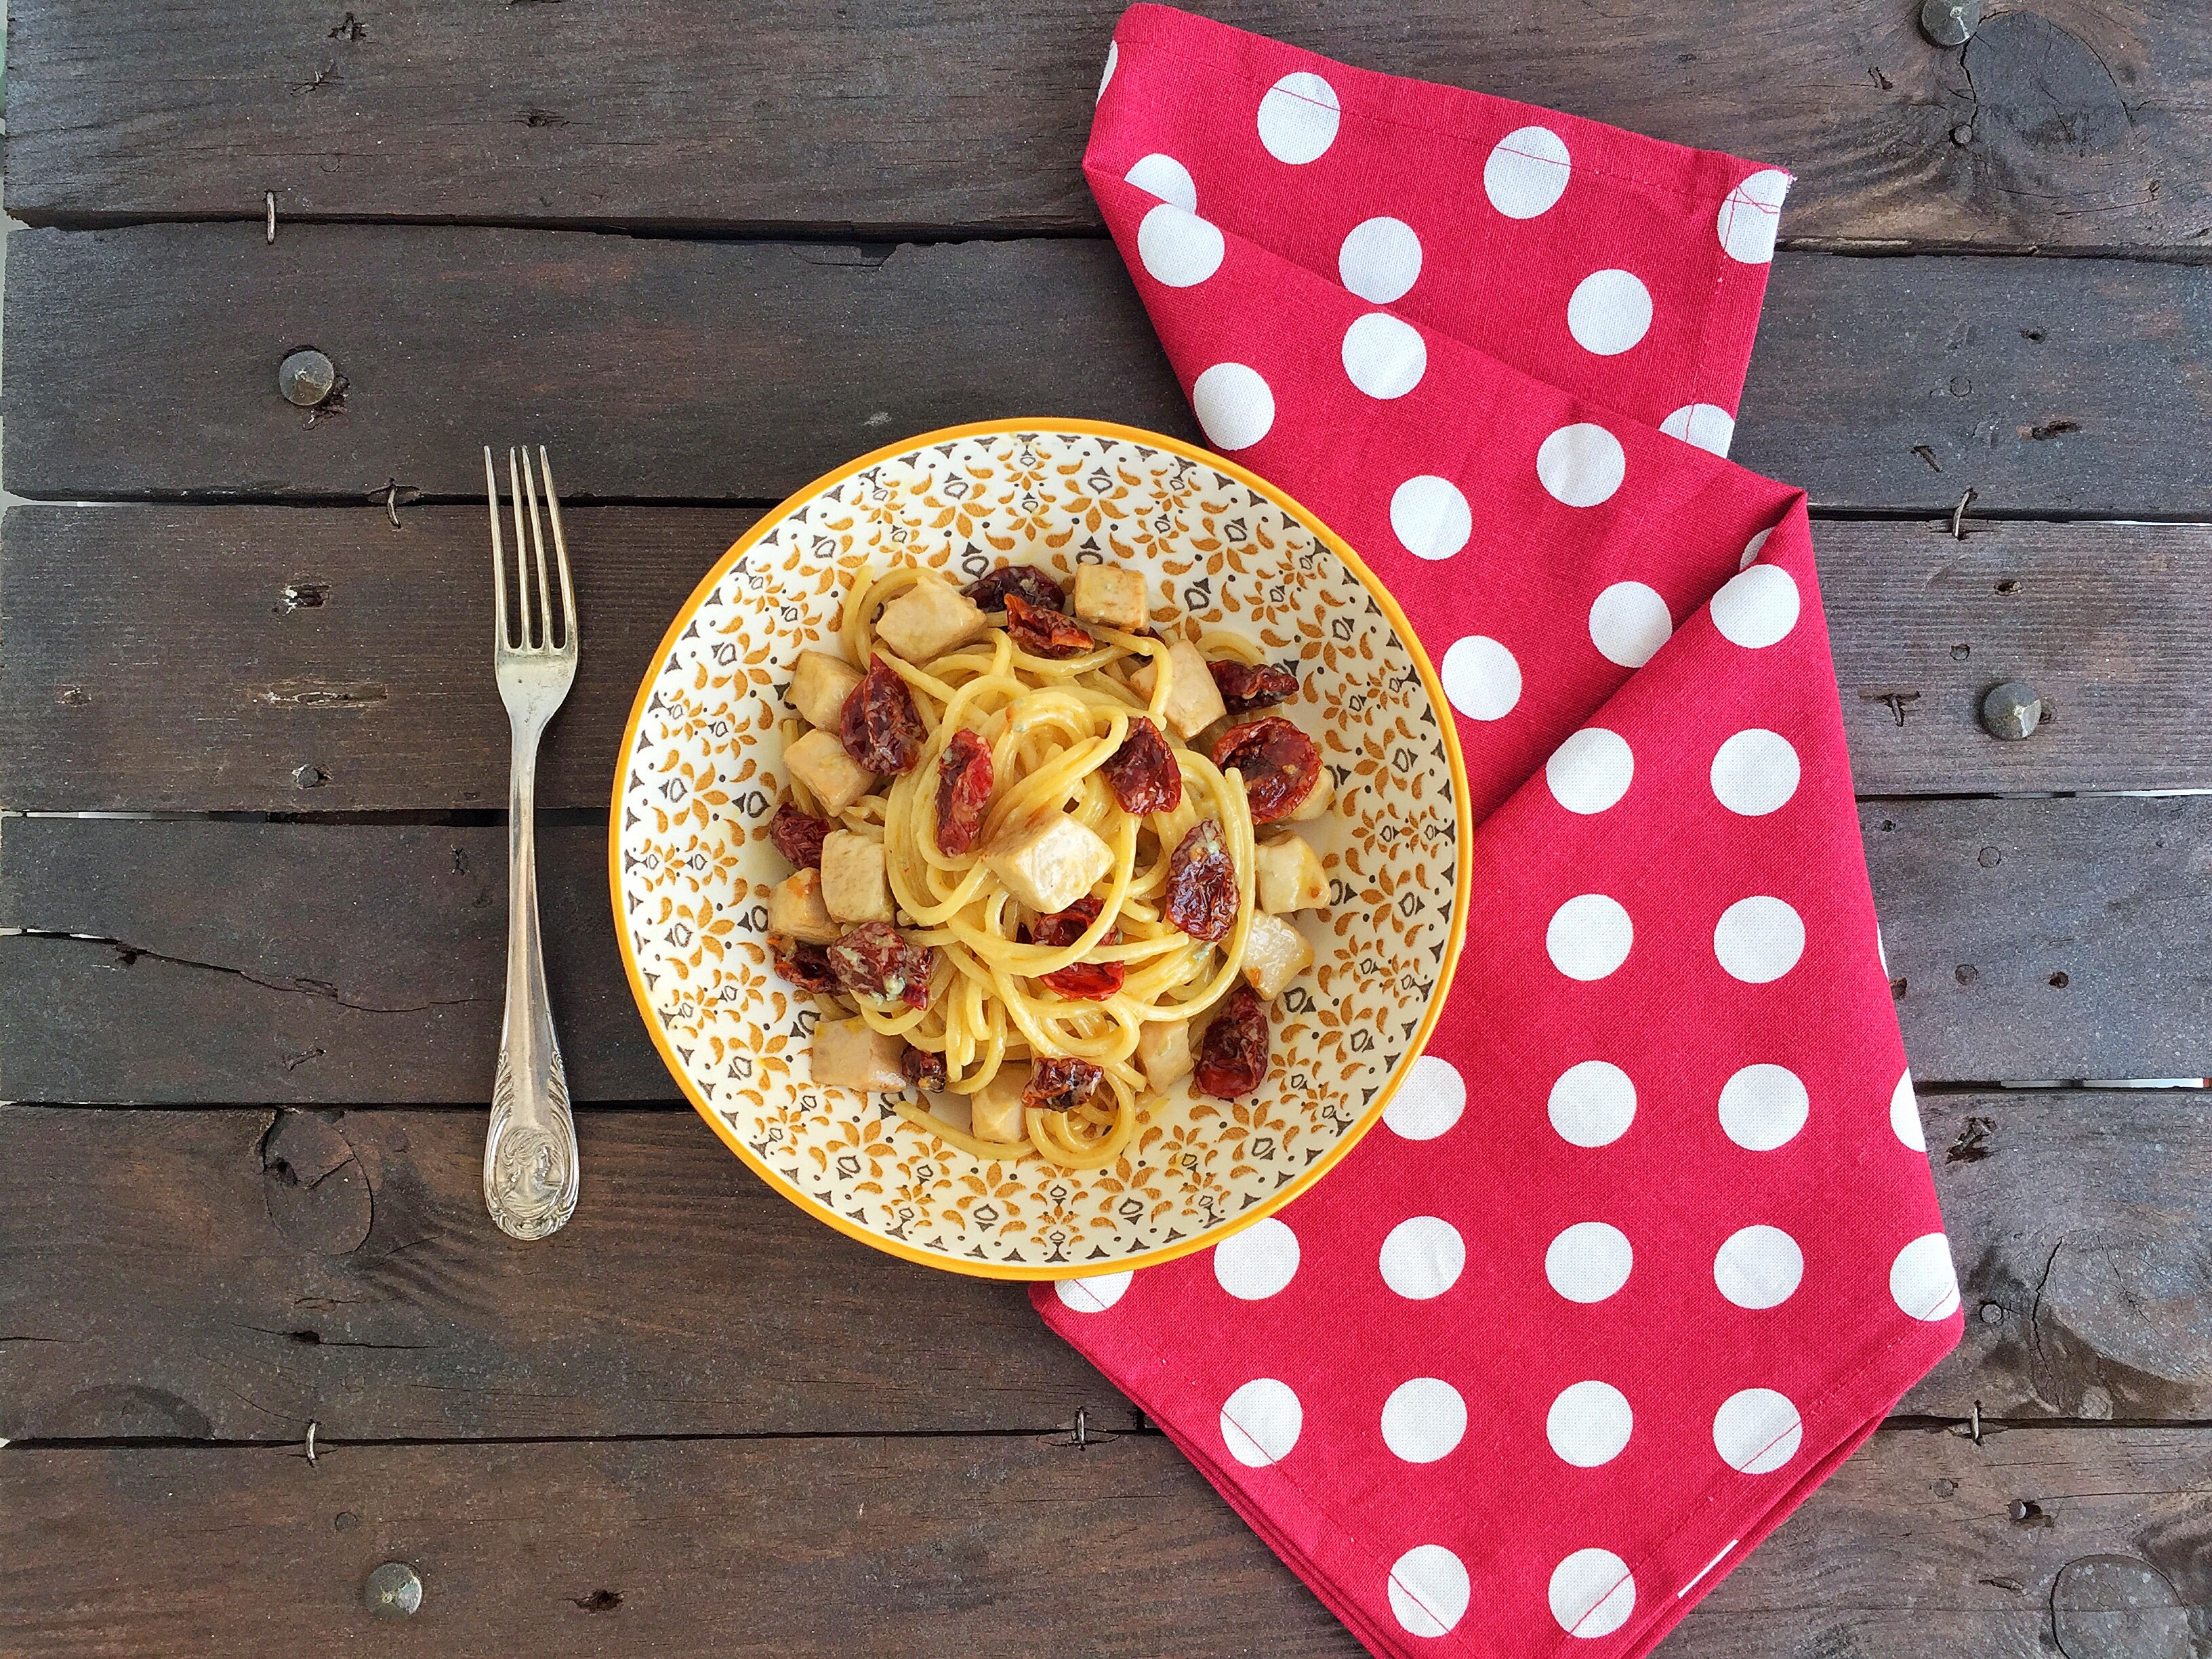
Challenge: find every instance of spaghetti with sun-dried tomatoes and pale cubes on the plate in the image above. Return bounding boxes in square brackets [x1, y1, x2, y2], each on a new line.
[768, 562, 1334, 1168]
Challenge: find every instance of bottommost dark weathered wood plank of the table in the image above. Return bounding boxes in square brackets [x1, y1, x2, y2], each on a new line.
[0, 1429, 2212, 1659]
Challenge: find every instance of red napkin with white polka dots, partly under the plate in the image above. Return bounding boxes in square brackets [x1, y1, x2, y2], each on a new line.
[1038, 7, 1960, 1654]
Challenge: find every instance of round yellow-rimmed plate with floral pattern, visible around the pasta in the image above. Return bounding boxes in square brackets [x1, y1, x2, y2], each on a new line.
[609, 420, 1469, 1279]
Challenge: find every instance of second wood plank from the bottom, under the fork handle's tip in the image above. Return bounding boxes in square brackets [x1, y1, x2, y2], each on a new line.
[0, 1090, 2212, 1442]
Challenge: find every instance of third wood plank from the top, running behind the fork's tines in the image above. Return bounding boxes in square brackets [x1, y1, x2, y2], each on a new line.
[0, 506, 2212, 812]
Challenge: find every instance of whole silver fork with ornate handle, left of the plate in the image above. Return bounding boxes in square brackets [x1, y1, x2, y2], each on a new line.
[485, 445, 577, 1239]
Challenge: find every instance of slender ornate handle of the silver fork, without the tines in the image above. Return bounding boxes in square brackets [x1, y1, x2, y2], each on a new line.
[485, 721, 577, 1239]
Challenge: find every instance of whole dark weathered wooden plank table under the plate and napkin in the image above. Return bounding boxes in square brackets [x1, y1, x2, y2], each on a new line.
[0, 0, 2212, 1659]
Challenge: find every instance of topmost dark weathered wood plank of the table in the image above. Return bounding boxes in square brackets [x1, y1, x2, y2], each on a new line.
[7, 0, 2212, 248]
